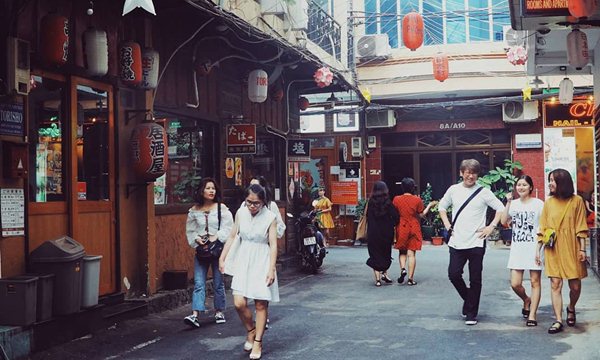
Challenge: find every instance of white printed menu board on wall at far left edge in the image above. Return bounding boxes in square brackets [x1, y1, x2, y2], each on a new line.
[0, 189, 25, 237]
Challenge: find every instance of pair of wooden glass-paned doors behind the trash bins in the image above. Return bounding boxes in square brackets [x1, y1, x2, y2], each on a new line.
[27, 74, 117, 295]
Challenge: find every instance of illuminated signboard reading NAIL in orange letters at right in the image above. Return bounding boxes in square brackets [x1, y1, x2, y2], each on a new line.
[544, 101, 594, 127]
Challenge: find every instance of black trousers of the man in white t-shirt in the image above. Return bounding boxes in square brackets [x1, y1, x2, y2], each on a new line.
[448, 247, 485, 318]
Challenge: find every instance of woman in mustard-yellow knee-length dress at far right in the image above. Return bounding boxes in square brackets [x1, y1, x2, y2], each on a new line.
[536, 169, 588, 334]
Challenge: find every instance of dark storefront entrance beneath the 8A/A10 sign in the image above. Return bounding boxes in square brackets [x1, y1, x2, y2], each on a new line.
[382, 130, 510, 199]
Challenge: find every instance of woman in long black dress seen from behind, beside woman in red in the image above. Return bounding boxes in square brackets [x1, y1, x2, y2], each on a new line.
[367, 181, 400, 286]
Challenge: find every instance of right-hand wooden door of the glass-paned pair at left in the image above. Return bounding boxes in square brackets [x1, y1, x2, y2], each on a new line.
[69, 77, 116, 294]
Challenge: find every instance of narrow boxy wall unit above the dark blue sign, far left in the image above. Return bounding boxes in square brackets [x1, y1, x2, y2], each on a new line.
[6, 36, 29, 95]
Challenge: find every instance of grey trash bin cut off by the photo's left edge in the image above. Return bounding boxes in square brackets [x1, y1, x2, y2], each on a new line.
[0, 275, 38, 326]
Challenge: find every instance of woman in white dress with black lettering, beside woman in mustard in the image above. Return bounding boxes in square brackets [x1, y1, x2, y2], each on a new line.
[500, 175, 544, 326]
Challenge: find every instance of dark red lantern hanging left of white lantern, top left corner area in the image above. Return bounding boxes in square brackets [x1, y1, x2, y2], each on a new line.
[40, 14, 69, 66]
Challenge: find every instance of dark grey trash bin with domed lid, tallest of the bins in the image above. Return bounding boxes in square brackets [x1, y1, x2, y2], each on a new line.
[30, 236, 85, 315]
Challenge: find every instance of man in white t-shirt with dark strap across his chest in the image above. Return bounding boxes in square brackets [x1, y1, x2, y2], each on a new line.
[438, 159, 504, 325]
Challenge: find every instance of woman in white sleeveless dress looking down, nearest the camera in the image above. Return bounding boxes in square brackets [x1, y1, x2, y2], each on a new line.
[219, 184, 279, 359]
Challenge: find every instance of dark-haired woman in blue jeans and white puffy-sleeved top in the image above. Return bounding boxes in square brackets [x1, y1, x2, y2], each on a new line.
[184, 178, 233, 328]
